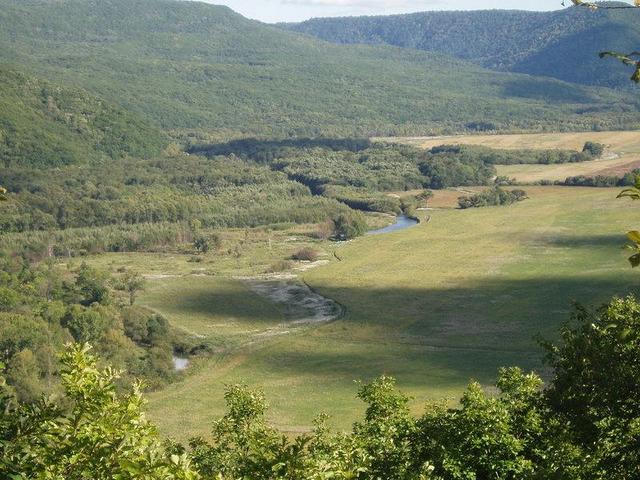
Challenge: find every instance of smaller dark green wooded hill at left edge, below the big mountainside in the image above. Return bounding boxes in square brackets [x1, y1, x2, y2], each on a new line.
[0, 67, 166, 168]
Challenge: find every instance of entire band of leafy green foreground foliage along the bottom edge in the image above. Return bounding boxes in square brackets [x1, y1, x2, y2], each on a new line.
[0, 297, 640, 480]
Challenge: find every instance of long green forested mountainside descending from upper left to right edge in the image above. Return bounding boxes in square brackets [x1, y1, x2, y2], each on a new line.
[0, 0, 639, 141]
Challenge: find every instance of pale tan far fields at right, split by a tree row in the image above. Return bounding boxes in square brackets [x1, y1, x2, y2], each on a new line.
[377, 132, 640, 182]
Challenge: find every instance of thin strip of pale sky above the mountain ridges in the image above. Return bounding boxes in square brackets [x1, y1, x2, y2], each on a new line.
[199, 0, 571, 23]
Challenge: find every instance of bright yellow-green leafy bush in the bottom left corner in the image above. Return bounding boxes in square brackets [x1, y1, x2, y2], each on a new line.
[0, 345, 197, 480]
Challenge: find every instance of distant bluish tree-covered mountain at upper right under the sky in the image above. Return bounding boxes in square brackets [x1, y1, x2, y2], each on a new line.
[283, 3, 640, 87]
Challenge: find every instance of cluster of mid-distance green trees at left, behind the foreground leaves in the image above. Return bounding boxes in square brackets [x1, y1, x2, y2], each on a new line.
[0, 254, 201, 403]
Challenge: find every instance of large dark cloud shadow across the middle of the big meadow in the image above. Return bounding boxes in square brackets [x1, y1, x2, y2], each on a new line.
[242, 274, 640, 387]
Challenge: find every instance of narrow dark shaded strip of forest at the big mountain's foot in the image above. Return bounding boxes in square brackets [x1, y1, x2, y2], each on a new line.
[187, 138, 371, 162]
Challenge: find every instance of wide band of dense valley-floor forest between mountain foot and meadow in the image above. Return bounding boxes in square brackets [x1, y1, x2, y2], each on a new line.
[0, 138, 608, 258]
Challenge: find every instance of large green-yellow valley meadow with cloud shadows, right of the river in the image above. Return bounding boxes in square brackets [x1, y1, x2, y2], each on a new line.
[117, 187, 640, 439]
